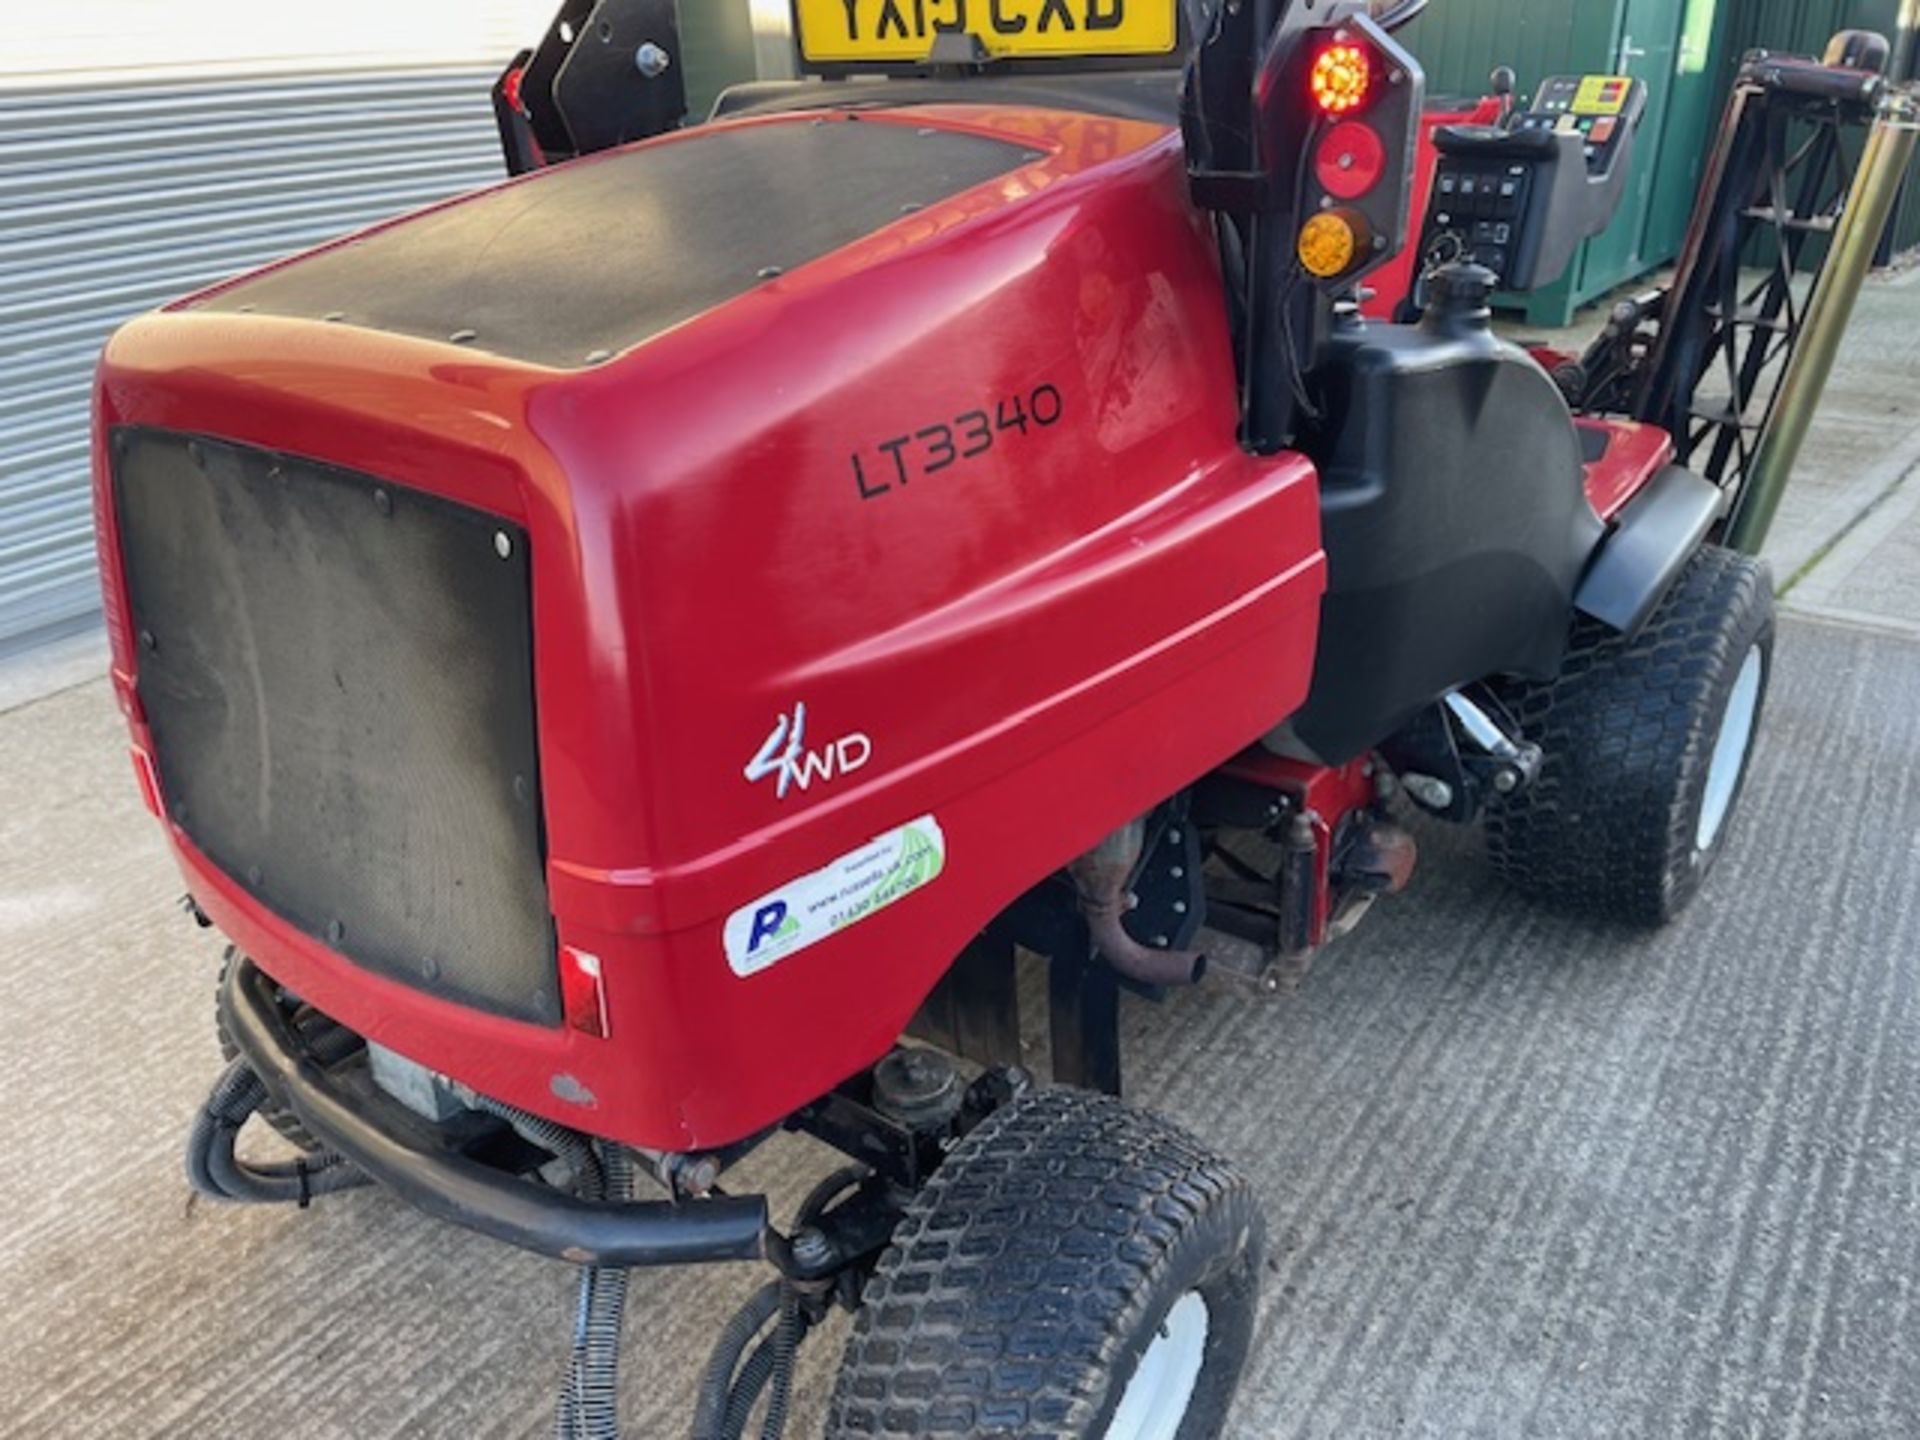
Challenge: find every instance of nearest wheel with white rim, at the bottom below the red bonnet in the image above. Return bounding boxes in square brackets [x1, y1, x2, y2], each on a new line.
[828, 1091, 1261, 1440]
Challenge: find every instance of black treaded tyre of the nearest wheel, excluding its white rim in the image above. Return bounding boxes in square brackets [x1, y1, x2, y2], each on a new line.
[828, 1091, 1260, 1440]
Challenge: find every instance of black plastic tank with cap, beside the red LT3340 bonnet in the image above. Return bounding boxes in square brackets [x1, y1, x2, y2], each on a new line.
[1290, 267, 1603, 764]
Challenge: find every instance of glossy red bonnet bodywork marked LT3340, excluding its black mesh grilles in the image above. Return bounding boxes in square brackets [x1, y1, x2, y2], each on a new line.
[94, 108, 1325, 1150]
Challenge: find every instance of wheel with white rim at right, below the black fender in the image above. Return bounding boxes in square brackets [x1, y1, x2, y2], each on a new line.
[1488, 545, 1774, 925]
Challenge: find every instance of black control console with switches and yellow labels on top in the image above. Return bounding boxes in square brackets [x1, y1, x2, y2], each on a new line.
[1415, 75, 1647, 303]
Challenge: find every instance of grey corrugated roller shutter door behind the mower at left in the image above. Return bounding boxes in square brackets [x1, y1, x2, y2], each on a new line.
[0, 65, 501, 655]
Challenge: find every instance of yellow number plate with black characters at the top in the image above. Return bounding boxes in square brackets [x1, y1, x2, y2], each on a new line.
[793, 0, 1179, 65]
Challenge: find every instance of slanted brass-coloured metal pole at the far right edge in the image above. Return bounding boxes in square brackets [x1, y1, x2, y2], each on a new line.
[1726, 85, 1920, 555]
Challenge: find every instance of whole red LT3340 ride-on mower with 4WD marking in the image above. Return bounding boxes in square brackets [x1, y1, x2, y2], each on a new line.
[96, 0, 1907, 1440]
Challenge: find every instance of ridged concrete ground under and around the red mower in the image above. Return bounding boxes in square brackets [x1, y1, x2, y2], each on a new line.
[11, 276, 1920, 1440]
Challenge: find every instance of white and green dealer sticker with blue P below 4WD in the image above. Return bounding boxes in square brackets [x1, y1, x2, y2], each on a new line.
[724, 814, 947, 979]
